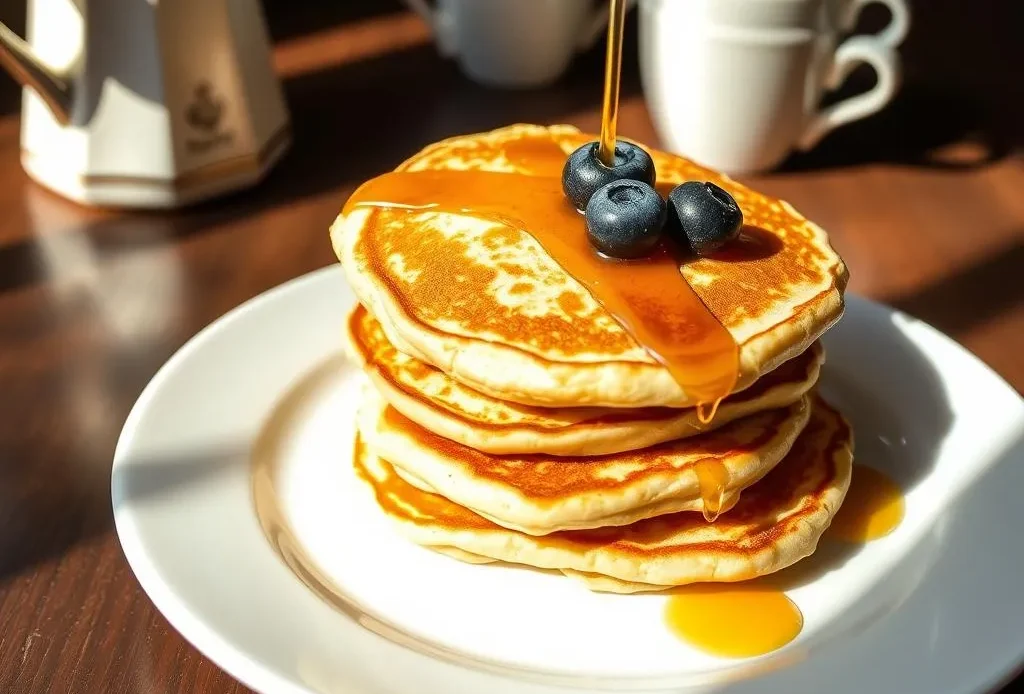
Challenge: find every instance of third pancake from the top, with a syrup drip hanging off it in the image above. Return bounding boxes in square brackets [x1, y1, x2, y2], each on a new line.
[357, 389, 810, 535]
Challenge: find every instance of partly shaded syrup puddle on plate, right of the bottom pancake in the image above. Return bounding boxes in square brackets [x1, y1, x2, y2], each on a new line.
[826, 465, 905, 543]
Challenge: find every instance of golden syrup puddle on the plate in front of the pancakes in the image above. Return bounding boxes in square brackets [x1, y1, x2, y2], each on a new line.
[665, 582, 804, 658]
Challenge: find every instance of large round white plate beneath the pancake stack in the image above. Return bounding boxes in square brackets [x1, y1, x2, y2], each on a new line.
[113, 268, 1024, 694]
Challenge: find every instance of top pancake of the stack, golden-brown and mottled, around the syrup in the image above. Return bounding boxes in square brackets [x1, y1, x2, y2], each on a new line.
[331, 125, 847, 407]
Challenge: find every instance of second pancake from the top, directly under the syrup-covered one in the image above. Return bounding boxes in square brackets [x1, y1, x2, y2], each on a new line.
[347, 306, 824, 456]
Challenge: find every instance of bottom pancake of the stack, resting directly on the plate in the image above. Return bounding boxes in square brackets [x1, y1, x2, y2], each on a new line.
[355, 397, 853, 592]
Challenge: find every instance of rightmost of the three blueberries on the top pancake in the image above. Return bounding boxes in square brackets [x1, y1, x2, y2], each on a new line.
[668, 181, 743, 256]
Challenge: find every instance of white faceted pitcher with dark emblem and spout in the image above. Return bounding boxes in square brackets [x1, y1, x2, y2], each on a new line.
[0, 0, 291, 208]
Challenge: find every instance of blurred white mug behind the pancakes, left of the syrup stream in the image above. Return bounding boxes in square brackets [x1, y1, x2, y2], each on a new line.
[406, 0, 626, 87]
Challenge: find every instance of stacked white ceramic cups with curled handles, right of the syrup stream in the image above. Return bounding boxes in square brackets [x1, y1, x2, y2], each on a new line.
[640, 0, 909, 174]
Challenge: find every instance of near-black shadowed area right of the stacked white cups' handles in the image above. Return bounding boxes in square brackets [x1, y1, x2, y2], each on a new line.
[782, 0, 1024, 171]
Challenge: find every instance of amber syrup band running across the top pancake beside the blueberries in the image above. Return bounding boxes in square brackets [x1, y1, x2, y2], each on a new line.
[345, 146, 737, 411]
